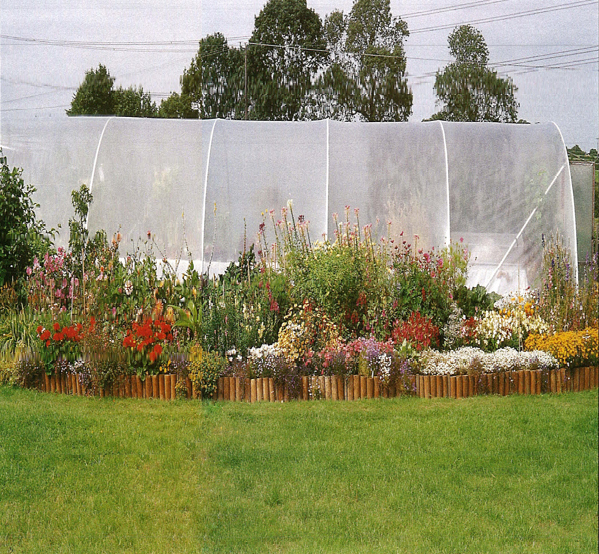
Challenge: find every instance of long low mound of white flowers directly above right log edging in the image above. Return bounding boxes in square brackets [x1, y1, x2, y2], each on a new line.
[418, 346, 558, 375]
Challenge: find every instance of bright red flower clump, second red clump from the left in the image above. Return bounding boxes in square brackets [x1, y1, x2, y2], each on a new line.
[123, 318, 173, 375]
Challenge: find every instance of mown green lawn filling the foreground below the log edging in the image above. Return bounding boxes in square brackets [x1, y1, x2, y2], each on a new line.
[0, 388, 598, 554]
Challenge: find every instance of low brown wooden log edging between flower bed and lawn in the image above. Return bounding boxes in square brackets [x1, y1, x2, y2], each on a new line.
[35, 367, 599, 403]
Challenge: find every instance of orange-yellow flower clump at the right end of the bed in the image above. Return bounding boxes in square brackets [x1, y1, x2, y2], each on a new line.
[524, 328, 599, 368]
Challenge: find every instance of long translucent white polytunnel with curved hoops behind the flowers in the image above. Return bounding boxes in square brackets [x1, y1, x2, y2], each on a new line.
[0, 117, 577, 293]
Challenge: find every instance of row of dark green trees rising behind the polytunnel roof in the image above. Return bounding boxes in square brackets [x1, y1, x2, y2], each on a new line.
[67, 0, 519, 122]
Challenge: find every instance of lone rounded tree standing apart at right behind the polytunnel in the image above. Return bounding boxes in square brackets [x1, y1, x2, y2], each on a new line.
[431, 25, 520, 123]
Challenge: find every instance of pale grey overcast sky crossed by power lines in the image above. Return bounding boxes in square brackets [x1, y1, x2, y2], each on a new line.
[0, 0, 599, 151]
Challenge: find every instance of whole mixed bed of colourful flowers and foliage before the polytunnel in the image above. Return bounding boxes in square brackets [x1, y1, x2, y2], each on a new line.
[0, 154, 598, 397]
